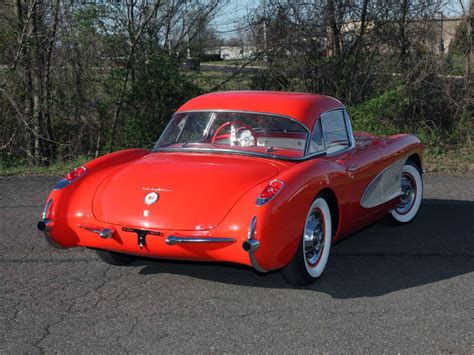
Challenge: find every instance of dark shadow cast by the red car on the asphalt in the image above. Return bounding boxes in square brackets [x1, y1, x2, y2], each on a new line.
[135, 199, 474, 299]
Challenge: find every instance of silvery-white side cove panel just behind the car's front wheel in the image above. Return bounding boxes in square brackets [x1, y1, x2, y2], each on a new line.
[360, 157, 407, 208]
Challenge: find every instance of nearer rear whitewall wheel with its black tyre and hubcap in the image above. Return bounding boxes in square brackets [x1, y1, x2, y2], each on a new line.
[282, 197, 332, 286]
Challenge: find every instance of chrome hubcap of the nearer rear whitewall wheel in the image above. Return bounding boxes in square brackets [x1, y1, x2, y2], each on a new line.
[304, 211, 324, 266]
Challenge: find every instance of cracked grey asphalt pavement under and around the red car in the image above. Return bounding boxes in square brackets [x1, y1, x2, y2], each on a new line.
[0, 175, 474, 354]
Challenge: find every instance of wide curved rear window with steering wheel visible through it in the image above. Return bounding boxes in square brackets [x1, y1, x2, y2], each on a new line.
[153, 111, 308, 158]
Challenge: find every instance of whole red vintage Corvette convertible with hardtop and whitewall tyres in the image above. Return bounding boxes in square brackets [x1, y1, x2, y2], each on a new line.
[38, 91, 423, 285]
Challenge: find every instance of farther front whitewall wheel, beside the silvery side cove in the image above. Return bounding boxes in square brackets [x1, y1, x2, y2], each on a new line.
[390, 161, 423, 224]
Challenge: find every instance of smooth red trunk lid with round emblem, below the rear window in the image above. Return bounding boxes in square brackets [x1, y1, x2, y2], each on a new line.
[92, 153, 278, 230]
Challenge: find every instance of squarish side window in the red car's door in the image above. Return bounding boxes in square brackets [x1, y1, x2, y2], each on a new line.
[320, 110, 350, 154]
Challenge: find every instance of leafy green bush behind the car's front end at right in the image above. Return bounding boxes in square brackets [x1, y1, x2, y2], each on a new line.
[348, 84, 470, 154]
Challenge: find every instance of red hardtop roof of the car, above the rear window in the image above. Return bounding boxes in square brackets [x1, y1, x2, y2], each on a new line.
[178, 91, 344, 130]
